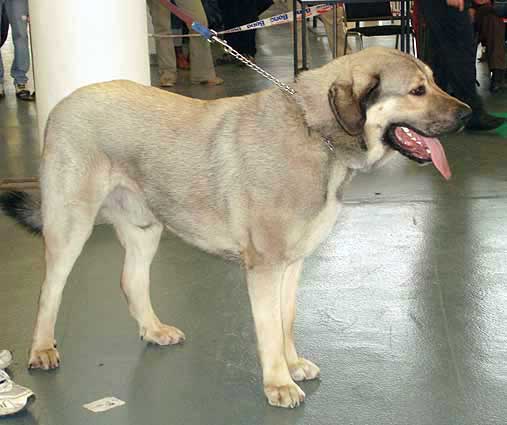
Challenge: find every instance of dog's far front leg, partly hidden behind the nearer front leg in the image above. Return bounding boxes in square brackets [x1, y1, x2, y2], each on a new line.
[281, 260, 320, 381]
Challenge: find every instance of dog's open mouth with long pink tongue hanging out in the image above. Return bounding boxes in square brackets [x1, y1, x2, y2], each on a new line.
[386, 125, 451, 180]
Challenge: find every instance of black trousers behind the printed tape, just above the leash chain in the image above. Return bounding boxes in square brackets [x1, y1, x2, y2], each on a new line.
[220, 0, 258, 56]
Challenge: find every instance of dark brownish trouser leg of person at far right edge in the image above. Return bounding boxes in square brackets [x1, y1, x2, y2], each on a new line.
[475, 5, 506, 93]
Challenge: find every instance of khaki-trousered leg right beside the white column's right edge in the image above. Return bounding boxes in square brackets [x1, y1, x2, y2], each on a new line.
[148, 0, 177, 87]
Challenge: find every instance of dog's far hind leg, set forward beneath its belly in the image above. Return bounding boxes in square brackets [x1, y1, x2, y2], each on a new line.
[107, 191, 185, 345]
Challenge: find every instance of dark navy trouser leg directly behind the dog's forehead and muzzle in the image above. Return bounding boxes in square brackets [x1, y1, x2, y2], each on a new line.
[420, 0, 483, 113]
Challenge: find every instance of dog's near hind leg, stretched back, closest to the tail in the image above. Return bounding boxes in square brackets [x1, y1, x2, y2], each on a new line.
[29, 179, 107, 370]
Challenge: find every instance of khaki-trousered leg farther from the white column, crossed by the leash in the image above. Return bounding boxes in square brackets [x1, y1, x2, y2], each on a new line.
[176, 0, 223, 85]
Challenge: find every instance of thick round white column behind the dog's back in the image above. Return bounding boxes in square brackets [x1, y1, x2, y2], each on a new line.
[29, 0, 150, 146]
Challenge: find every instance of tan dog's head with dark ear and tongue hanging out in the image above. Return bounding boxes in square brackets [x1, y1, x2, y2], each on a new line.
[297, 47, 471, 178]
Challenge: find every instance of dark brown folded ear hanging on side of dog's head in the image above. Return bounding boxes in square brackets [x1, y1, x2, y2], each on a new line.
[327, 73, 380, 136]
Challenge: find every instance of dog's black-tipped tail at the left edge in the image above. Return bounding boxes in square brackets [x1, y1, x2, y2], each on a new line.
[0, 192, 42, 235]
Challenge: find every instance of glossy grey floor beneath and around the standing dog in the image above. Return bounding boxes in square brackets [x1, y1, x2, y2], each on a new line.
[0, 12, 507, 425]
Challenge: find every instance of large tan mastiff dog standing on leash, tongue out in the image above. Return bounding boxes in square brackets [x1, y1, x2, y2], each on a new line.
[1, 48, 470, 407]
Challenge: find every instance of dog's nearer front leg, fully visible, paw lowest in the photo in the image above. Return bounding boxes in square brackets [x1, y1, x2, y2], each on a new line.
[247, 265, 305, 407]
